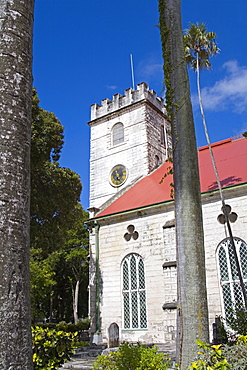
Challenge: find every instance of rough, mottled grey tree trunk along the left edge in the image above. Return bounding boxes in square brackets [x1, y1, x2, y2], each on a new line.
[0, 0, 34, 370]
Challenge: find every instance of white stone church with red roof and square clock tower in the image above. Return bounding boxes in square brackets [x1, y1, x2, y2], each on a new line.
[88, 83, 247, 345]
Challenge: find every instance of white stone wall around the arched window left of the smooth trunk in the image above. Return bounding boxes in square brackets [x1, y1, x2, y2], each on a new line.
[89, 210, 176, 343]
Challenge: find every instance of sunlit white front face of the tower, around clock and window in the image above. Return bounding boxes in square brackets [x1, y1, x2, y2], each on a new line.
[90, 106, 147, 207]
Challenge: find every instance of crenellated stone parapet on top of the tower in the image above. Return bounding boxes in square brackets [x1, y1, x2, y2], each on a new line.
[91, 82, 166, 121]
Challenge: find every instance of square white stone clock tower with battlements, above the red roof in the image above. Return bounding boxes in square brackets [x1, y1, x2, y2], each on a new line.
[88, 83, 171, 209]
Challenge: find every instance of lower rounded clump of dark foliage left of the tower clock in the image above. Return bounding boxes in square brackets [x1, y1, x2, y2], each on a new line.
[31, 166, 82, 258]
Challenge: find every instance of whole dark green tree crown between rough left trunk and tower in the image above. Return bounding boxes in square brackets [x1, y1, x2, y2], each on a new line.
[30, 89, 82, 258]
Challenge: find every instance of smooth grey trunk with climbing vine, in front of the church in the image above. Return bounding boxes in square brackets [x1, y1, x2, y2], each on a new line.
[159, 0, 209, 370]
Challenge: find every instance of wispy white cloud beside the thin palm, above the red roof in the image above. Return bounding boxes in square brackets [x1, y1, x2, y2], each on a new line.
[192, 60, 247, 114]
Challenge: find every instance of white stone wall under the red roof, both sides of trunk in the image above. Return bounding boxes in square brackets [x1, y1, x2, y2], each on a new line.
[88, 188, 247, 343]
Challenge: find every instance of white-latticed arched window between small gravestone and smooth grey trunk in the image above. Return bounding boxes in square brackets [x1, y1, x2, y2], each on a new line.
[122, 253, 147, 330]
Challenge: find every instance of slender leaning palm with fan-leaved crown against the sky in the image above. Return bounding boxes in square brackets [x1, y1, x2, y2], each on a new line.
[183, 23, 247, 307]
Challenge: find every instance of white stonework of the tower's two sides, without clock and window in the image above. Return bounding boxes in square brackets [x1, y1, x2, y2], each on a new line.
[89, 86, 171, 208]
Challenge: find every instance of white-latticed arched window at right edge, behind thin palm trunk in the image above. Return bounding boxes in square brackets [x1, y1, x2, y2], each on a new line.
[217, 238, 247, 318]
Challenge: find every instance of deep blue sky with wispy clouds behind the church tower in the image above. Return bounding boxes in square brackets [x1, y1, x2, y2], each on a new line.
[33, 0, 247, 209]
